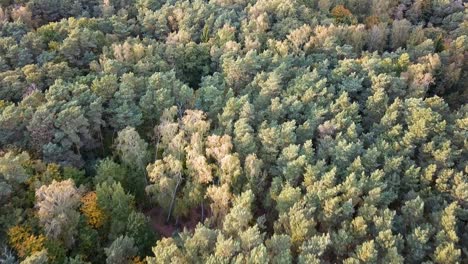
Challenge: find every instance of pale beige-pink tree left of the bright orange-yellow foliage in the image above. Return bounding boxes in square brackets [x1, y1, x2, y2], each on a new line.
[36, 179, 81, 248]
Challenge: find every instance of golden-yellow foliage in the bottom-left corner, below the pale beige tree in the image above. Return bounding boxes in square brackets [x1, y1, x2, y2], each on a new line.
[8, 226, 45, 258]
